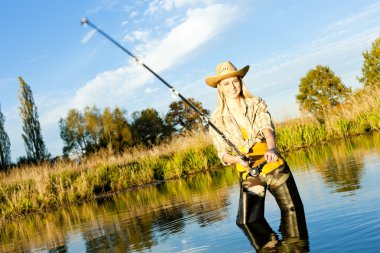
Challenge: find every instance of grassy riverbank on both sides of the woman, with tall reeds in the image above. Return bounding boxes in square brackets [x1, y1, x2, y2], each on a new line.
[0, 86, 380, 222]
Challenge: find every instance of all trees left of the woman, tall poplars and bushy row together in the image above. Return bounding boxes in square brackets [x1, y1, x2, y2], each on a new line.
[0, 82, 210, 170]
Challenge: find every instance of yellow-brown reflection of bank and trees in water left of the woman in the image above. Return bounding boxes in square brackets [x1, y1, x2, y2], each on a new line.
[0, 169, 237, 252]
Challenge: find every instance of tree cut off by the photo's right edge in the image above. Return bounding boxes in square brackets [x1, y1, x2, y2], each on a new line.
[359, 38, 380, 87]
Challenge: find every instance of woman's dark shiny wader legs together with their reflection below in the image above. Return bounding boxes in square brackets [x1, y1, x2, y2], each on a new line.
[236, 166, 309, 252]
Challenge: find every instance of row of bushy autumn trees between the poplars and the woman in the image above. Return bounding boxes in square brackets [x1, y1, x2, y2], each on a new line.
[59, 98, 210, 156]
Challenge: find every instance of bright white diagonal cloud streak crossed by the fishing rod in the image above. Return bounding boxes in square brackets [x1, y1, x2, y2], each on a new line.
[70, 4, 238, 108]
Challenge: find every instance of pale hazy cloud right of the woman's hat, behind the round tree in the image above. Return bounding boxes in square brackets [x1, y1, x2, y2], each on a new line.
[245, 26, 380, 120]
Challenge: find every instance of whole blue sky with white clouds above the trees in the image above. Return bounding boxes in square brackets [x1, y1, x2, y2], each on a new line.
[0, 0, 380, 162]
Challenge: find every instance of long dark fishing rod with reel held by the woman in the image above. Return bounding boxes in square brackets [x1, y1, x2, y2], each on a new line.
[81, 18, 266, 176]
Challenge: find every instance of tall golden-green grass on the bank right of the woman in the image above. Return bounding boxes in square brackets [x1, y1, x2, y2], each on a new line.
[277, 87, 380, 152]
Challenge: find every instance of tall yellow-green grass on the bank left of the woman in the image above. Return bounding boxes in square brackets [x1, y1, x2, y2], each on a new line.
[0, 133, 218, 221]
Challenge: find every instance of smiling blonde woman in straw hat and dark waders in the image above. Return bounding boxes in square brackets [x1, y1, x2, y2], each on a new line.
[205, 62, 307, 251]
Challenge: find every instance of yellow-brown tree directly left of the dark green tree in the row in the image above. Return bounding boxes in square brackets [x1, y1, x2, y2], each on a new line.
[100, 107, 133, 153]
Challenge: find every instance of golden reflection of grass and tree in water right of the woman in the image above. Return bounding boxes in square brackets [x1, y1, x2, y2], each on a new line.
[287, 134, 380, 194]
